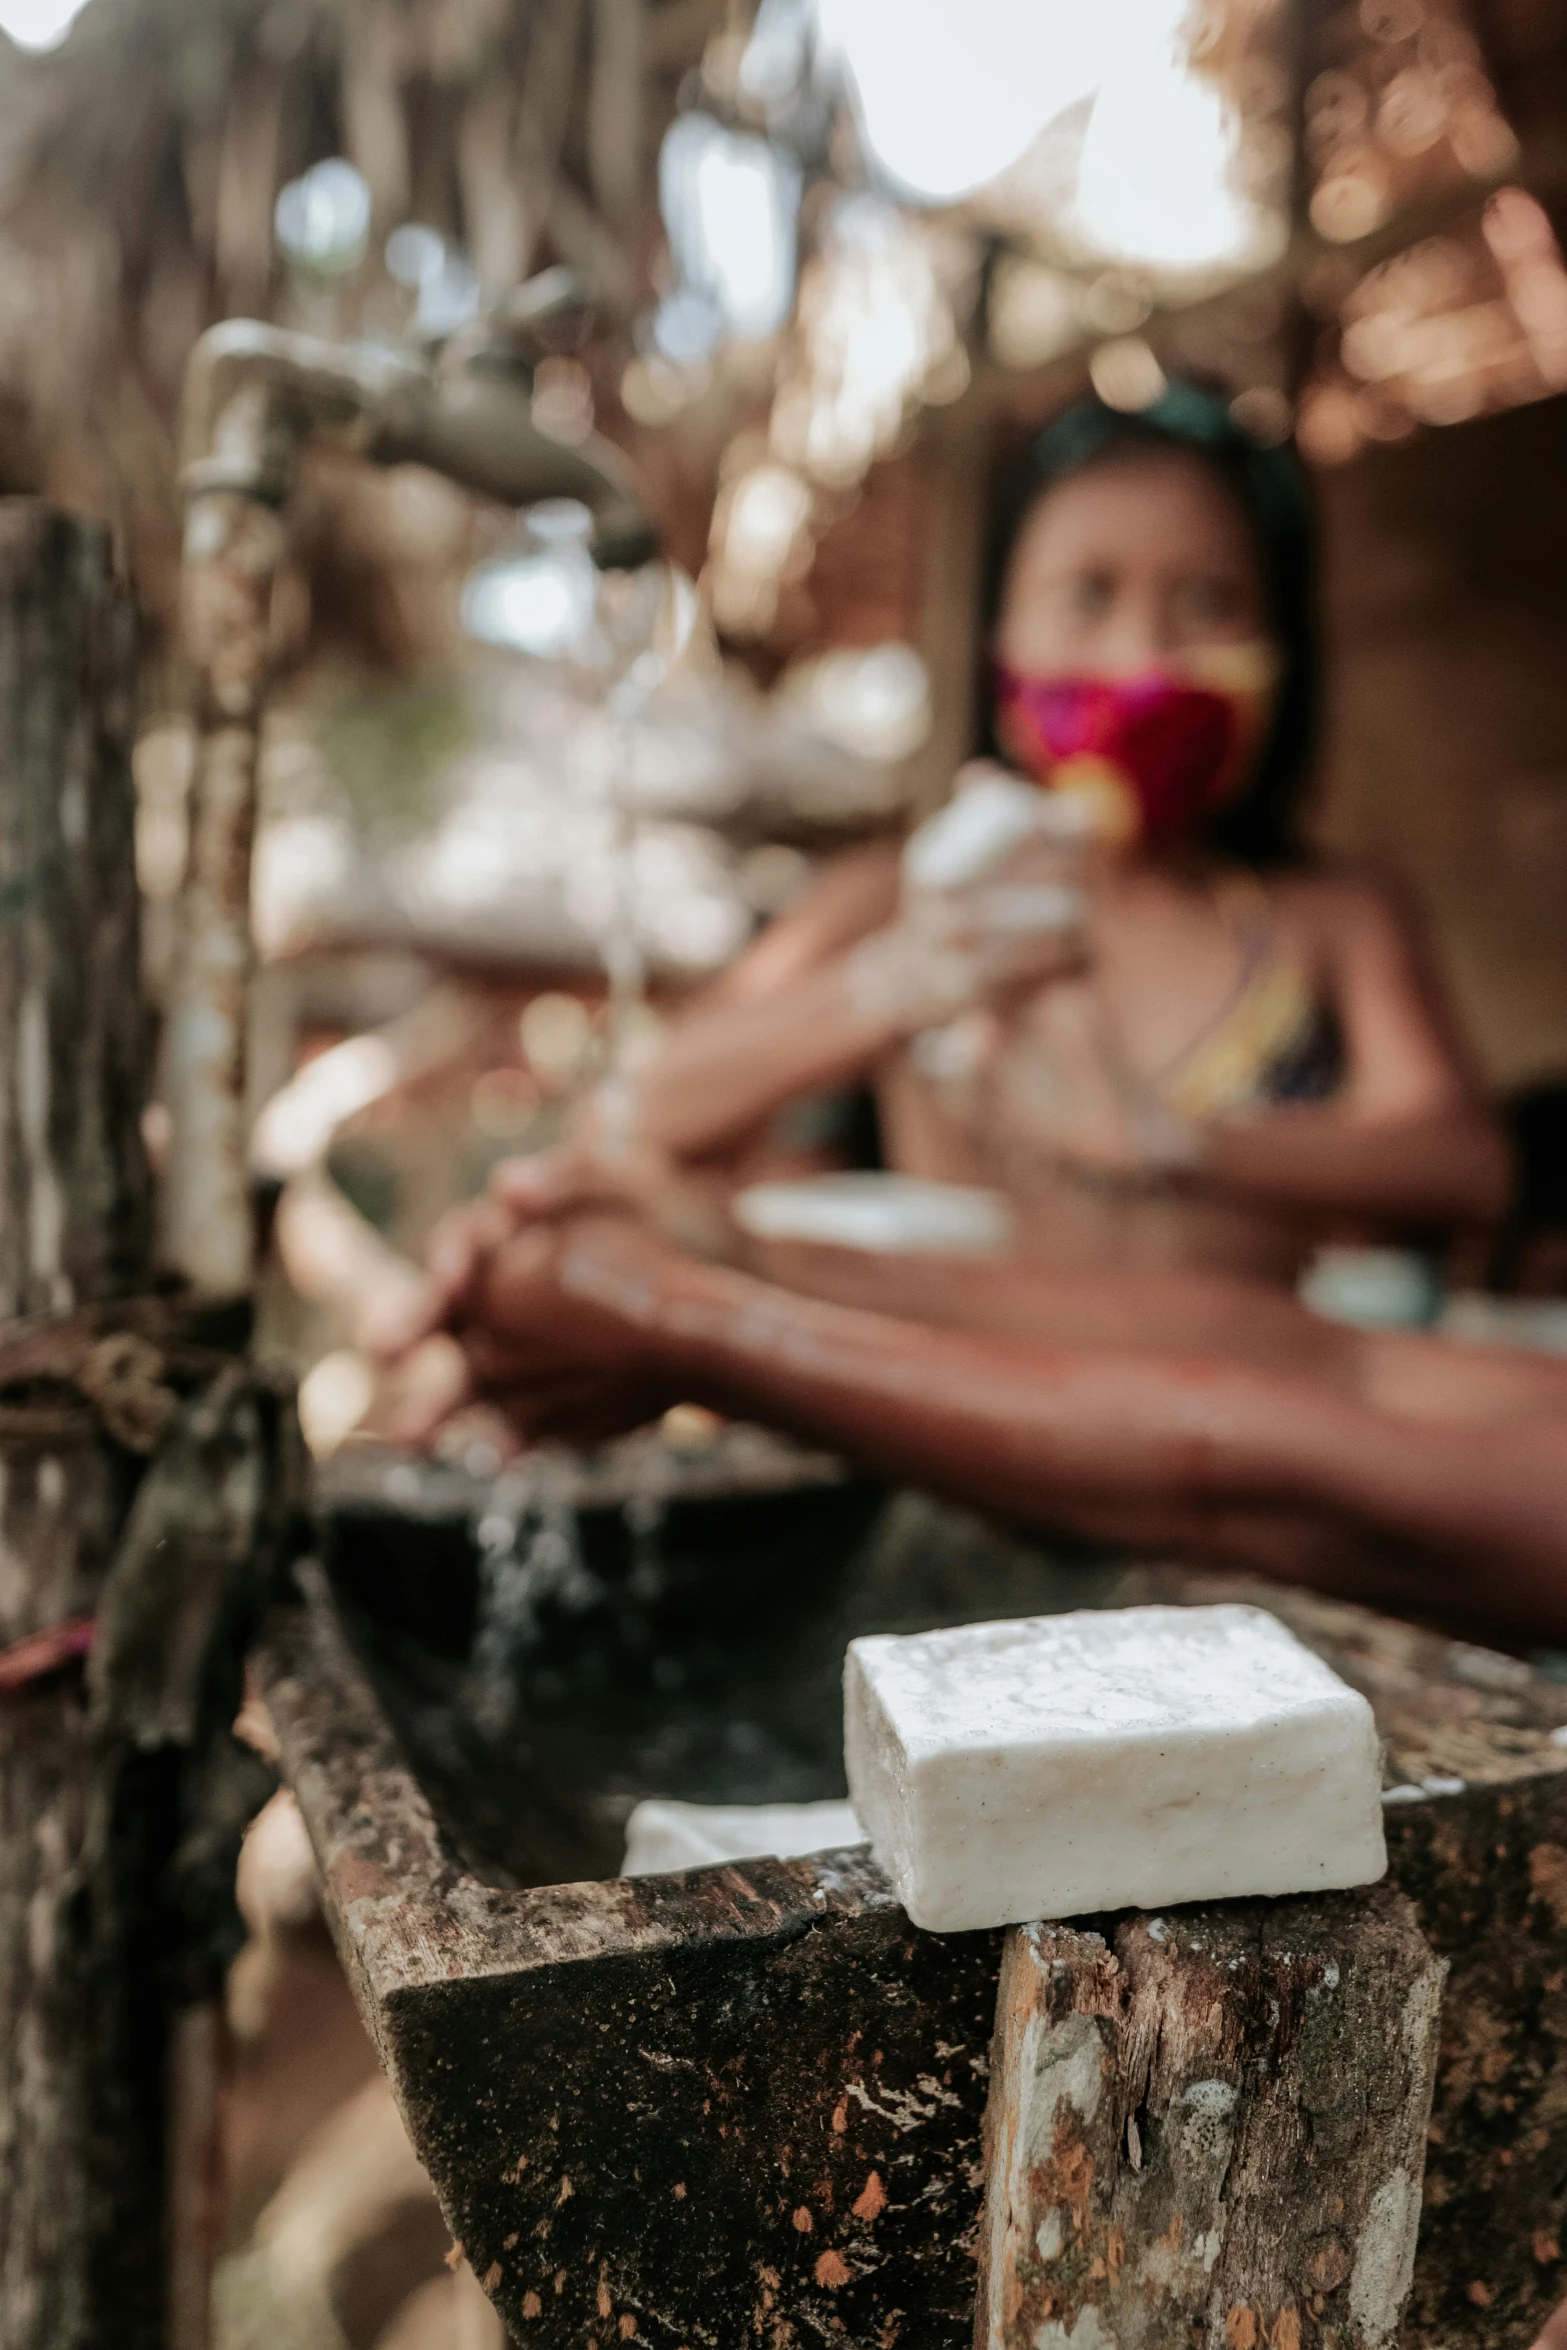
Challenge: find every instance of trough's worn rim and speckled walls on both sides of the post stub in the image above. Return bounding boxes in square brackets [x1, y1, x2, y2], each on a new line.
[263, 1537, 1567, 2350]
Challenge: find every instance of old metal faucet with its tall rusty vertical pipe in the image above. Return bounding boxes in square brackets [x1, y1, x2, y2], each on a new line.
[162, 300, 658, 1297]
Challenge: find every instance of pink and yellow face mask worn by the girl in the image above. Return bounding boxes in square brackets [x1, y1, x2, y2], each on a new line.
[996, 644, 1278, 848]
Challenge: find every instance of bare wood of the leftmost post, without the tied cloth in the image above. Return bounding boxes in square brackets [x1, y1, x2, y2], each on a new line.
[0, 501, 169, 2350]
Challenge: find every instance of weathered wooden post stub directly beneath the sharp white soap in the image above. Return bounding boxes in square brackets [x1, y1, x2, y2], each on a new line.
[975, 1887, 1447, 2350]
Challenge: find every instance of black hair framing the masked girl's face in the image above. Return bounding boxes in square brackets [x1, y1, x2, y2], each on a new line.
[982, 383, 1320, 865]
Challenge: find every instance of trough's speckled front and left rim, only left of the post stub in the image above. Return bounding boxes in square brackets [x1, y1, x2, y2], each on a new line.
[263, 1560, 1001, 2350]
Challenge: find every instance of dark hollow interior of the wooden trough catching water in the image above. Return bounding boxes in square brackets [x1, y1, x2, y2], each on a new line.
[322, 1431, 1121, 1885]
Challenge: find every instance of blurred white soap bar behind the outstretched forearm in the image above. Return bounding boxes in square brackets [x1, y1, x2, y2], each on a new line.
[731, 1173, 1013, 1257]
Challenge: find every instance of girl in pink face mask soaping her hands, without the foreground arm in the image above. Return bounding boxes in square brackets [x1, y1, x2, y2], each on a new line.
[425, 388, 1508, 1285]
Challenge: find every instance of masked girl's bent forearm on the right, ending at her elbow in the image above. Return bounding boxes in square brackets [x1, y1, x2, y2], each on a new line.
[1198, 1107, 1511, 1227]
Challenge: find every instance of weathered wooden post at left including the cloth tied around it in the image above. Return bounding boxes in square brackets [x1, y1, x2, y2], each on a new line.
[0, 501, 298, 2350]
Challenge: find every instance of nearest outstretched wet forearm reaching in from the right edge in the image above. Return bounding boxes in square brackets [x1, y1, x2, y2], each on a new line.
[561, 1238, 1567, 1638]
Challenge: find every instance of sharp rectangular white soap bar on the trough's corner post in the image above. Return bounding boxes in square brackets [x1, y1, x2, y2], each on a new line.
[843, 1607, 1388, 1934]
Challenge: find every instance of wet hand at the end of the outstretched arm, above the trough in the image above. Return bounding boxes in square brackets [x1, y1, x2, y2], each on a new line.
[395, 1215, 677, 1443]
